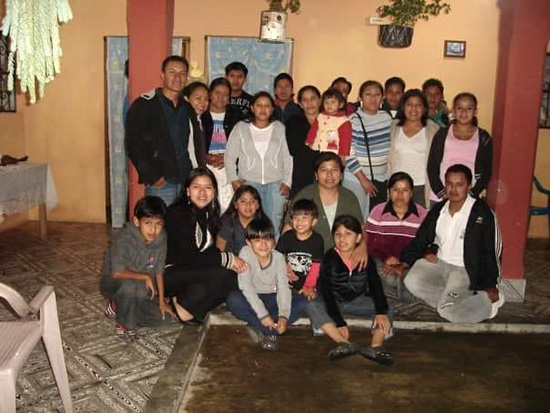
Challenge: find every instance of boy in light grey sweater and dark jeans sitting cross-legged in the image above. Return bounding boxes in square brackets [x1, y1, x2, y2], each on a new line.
[226, 218, 307, 350]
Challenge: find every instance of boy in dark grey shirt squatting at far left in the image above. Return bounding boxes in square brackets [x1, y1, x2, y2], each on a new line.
[100, 196, 174, 337]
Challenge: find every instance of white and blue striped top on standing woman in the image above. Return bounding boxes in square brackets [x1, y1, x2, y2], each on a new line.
[346, 109, 392, 182]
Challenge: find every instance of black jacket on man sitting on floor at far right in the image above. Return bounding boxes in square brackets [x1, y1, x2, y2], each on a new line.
[401, 199, 502, 291]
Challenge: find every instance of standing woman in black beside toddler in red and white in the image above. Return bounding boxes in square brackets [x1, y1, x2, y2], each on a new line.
[286, 85, 321, 199]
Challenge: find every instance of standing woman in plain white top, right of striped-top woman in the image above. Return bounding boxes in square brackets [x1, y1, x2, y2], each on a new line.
[389, 89, 439, 208]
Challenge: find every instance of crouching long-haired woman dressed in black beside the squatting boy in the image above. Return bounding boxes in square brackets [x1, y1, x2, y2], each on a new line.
[164, 168, 247, 325]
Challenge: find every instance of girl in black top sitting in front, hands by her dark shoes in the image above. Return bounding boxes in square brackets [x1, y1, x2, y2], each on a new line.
[307, 215, 393, 365]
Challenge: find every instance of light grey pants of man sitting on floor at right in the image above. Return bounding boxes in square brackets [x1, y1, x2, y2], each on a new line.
[405, 259, 492, 323]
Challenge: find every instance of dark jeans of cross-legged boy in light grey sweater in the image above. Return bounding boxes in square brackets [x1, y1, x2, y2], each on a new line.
[225, 291, 307, 336]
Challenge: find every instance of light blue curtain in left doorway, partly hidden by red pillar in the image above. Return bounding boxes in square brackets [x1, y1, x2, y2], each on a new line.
[106, 36, 183, 228]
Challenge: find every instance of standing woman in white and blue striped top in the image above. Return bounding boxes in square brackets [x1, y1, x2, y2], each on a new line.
[343, 80, 392, 218]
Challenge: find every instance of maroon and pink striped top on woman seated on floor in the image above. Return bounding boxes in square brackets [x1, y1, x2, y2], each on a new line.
[365, 200, 427, 261]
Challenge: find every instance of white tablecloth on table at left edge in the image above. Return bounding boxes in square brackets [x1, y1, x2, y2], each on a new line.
[0, 162, 58, 222]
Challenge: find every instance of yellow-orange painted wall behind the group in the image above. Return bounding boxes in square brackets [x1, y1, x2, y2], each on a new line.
[0, 0, 499, 222]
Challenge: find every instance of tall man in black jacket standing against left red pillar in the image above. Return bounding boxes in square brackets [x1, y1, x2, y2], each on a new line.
[126, 56, 205, 205]
